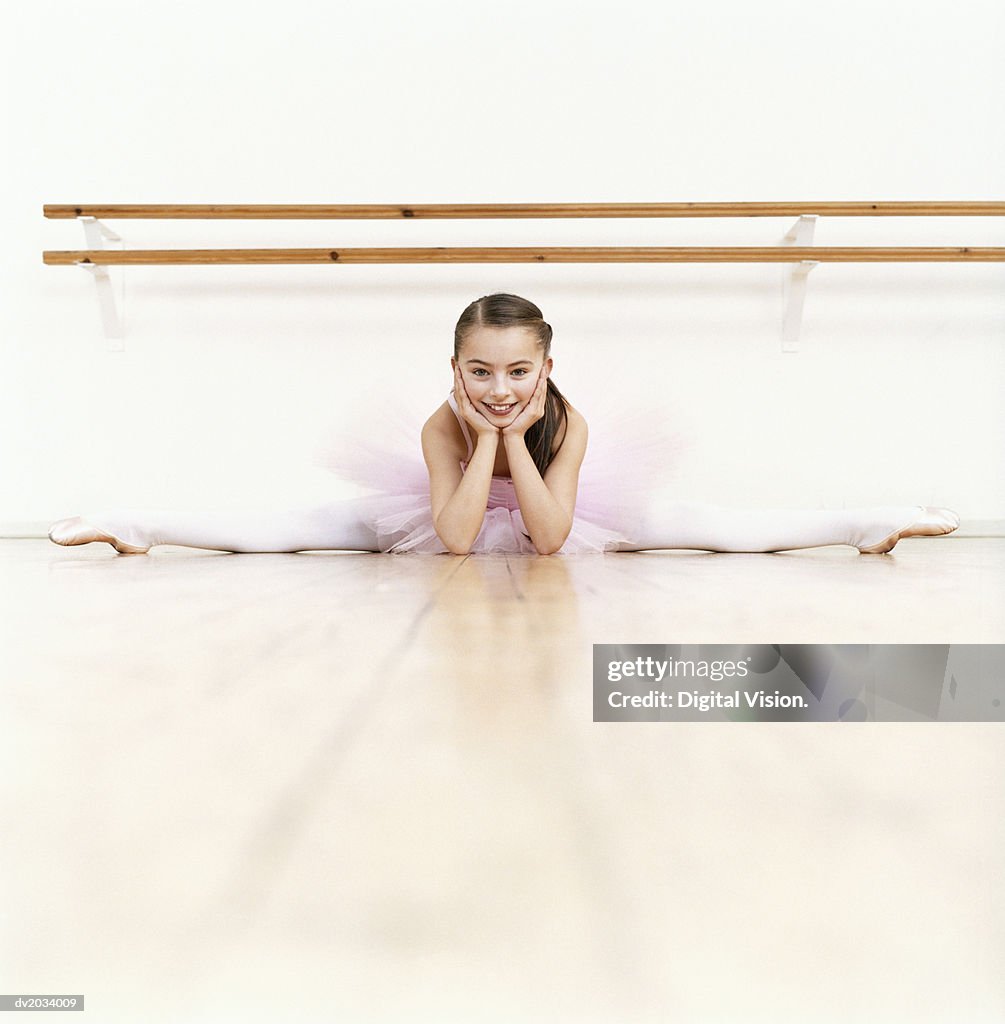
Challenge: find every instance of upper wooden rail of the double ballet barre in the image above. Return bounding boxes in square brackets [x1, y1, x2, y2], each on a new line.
[42, 202, 1005, 220]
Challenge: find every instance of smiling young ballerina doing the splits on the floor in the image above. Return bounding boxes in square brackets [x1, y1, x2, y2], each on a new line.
[49, 294, 960, 555]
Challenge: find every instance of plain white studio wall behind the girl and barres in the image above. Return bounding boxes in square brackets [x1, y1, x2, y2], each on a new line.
[0, 0, 1005, 536]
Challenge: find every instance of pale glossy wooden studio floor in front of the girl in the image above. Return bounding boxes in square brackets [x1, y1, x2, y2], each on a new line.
[0, 538, 1005, 1024]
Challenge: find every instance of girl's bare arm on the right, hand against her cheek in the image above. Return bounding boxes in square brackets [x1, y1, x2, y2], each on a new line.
[502, 376, 588, 555]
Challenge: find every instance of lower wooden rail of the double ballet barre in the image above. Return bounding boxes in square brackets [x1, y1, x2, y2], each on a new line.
[42, 246, 1005, 266]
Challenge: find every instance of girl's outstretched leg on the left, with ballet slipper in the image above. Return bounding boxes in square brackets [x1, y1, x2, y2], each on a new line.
[49, 499, 378, 554]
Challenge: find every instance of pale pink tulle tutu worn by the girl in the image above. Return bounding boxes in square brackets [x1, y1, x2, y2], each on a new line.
[316, 392, 681, 555]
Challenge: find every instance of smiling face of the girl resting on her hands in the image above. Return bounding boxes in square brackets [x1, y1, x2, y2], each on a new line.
[450, 327, 552, 427]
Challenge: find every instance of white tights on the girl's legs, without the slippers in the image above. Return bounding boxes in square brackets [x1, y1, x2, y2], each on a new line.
[78, 496, 923, 552]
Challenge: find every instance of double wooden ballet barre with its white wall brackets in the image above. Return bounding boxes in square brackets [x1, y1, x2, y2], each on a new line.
[42, 201, 1005, 351]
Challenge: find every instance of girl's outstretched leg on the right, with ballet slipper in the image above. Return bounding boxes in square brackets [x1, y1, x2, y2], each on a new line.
[619, 495, 960, 553]
